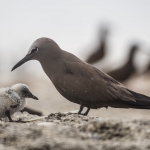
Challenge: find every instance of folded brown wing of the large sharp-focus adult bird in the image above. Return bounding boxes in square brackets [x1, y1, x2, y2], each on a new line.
[57, 61, 135, 102]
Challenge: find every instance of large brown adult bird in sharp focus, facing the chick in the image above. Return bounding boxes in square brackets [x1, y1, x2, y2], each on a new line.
[12, 38, 150, 115]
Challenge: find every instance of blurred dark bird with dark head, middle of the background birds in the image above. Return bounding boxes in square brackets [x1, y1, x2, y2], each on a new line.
[107, 44, 139, 82]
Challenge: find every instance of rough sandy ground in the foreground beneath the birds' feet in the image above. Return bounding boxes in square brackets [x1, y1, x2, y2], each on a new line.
[0, 112, 150, 150]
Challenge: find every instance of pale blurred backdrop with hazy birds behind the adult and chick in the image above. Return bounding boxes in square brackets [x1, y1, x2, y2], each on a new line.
[0, 0, 150, 119]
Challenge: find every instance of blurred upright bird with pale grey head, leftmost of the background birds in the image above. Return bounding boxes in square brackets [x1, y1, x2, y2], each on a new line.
[86, 27, 108, 64]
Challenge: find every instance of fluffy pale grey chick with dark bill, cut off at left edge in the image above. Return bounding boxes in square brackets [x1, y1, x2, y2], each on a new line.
[0, 83, 38, 122]
